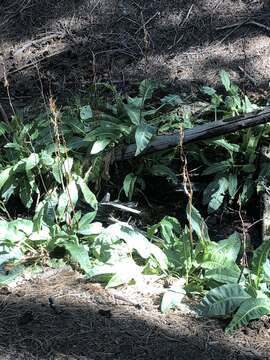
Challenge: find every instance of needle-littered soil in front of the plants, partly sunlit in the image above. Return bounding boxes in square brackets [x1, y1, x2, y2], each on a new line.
[0, 268, 270, 360]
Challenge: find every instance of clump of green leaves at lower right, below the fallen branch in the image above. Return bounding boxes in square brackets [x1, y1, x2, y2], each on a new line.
[148, 207, 270, 333]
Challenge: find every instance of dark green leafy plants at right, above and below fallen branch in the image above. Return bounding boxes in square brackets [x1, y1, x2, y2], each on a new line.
[197, 71, 269, 212]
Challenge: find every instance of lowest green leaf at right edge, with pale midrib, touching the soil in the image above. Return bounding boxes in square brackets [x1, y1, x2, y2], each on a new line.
[225, 298, 270, 334]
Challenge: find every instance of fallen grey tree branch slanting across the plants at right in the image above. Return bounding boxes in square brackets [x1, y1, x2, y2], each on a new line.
[114, 106, 270, 161]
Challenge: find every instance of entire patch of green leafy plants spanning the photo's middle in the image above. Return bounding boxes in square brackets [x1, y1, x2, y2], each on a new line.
[0, 71, 270, 332]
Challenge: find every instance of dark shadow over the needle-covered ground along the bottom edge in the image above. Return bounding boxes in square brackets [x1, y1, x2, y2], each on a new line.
[0, 288, 266, 360]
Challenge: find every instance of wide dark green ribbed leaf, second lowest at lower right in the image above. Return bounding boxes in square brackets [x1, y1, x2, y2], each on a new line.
[198, 284, 250, 317]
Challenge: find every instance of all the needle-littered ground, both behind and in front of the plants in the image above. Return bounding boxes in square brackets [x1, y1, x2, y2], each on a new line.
[0, 0, 270, 360]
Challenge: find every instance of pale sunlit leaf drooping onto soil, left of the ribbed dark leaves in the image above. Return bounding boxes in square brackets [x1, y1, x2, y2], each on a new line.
[160, 279, 186, 314]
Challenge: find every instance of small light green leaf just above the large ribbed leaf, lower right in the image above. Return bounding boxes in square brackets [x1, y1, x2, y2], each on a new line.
[205, 263, 241, 284]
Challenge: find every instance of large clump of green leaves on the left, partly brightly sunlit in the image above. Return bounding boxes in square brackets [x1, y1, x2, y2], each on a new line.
[0, 91, 170, 286]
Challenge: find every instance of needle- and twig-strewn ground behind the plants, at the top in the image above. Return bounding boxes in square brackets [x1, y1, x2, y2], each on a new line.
[0, 0, 270, 106]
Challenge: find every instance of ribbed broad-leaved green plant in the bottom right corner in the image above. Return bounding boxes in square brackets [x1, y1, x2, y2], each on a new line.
[196, 233, 270, 332]
